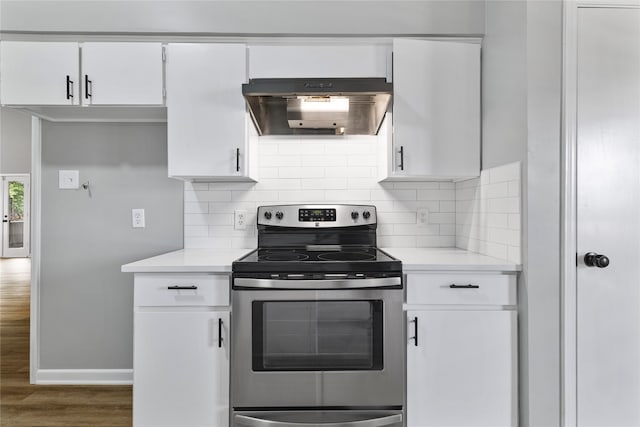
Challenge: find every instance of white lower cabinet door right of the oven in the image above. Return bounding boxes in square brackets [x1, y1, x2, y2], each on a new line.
[407, 310, 518, 427]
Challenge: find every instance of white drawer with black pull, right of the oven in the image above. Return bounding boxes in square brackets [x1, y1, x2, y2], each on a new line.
[407, 274, 517, 305]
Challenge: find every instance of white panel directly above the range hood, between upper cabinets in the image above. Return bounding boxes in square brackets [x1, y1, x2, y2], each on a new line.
[249, 45, 391, 79]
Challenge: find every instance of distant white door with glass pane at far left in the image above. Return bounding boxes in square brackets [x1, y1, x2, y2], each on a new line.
[1, 175, 30, 257]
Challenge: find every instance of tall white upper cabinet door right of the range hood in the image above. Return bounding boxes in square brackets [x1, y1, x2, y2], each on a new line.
[390, 40, 480, 178]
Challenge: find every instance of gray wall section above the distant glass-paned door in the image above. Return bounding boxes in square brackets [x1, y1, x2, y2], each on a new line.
[0, 107, 31, 174]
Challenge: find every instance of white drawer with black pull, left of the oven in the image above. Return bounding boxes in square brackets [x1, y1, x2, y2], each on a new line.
[133, 274, 229, 307]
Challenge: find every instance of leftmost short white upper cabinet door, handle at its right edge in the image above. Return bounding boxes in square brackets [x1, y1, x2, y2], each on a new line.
[0, 41, 80, 105]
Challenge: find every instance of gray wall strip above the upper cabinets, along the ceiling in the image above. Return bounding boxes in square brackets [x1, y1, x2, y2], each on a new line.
[0, 0, 484, 35]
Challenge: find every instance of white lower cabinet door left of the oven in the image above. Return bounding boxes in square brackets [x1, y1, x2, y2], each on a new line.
[133, 311, 230, 427]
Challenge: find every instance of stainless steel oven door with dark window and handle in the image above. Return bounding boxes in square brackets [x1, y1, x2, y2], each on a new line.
[231, 277, 404, 410]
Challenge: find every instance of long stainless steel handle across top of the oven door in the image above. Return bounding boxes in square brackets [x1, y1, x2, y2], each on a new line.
[233, 277, 402, 290]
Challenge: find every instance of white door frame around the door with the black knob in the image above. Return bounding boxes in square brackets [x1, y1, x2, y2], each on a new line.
[560, 0, 640, 427]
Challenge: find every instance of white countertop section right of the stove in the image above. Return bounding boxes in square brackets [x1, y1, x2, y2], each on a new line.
[381, 248, 521, 273]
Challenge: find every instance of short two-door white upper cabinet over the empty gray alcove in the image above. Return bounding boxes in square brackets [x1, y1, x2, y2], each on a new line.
[0, 42, 163, 106]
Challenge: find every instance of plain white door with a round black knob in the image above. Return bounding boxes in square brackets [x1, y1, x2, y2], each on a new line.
[576, 8, 640, 427]
